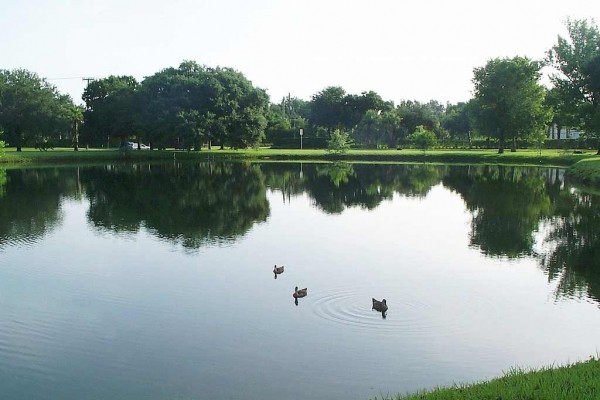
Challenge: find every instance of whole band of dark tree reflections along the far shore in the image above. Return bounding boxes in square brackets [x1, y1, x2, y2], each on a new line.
[0, 162, 600, 303]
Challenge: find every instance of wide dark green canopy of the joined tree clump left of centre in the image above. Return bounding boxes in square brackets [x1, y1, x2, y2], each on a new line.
[84, 61, 269, 149]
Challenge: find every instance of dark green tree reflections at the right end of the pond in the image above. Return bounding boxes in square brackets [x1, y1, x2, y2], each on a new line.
[444, 166, 600, 303]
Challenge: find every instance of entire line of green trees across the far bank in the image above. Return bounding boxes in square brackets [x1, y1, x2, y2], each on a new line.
[0, 19, 600, 154]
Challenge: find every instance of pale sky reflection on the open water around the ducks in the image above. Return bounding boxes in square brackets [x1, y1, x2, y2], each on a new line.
[0, 185, 600, 399]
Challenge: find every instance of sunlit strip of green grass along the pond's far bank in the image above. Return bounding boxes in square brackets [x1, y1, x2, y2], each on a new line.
[0, 147, 600, 187]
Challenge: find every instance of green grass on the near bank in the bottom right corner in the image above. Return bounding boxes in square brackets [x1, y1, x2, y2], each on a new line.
[378, 359, 600, 400]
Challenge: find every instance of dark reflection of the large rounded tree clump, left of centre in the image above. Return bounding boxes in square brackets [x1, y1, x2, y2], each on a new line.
[82, 163, 269, 249]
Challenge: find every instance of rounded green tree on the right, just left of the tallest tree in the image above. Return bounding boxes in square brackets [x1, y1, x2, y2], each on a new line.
[473, 57, 549, 153]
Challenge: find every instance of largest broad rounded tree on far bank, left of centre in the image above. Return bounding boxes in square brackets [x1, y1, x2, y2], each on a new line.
[141, 61, 269, 149]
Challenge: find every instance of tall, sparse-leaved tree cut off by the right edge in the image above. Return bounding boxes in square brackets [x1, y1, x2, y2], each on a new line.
[548, 19, 600, 155]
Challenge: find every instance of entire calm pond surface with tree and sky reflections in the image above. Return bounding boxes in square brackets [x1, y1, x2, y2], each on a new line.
[0, 163, 600, 400]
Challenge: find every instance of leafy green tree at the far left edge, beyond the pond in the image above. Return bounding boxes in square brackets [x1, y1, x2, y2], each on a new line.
[0, 69, 74, 151]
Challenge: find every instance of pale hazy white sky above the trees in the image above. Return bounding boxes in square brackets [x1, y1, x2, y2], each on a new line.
[0, 0, 600, 103]
